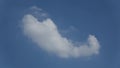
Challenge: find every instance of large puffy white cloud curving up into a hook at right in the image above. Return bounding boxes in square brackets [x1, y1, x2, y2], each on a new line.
[23, 10, 100, 58]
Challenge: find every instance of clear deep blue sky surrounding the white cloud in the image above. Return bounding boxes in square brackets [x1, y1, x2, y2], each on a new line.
[0, 0, 120, 68]
